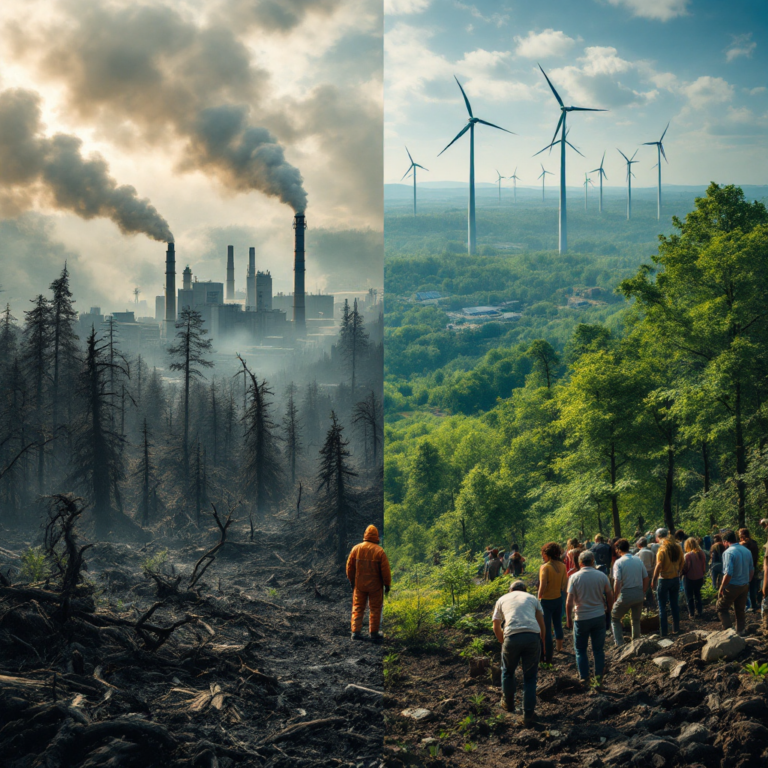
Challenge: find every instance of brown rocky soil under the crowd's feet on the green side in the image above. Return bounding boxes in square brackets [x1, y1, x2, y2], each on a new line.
[384, 584, 768, 768]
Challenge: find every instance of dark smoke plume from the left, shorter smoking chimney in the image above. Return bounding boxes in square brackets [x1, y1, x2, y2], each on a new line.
[0, 89, 173, 241]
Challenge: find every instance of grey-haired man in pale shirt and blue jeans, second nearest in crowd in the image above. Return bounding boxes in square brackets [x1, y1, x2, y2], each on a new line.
[565, 550, 613, 685]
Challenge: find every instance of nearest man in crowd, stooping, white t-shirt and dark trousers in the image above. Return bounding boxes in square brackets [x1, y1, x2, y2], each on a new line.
[493, 581, 544, 725]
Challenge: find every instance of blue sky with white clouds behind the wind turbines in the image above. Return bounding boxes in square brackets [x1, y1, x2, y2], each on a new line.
[384, 0, 768, 186]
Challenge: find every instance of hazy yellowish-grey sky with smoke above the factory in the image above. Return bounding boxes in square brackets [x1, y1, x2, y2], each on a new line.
[0, 0, 382, 315]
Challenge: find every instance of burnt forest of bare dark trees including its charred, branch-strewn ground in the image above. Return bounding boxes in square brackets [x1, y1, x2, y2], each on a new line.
[0, 267, 383, 768]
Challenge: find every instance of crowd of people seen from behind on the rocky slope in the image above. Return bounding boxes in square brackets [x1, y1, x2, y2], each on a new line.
[486, 519, 768, 723]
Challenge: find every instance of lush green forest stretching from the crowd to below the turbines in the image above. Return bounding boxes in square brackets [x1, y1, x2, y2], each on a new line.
[384, 184, 768, 572]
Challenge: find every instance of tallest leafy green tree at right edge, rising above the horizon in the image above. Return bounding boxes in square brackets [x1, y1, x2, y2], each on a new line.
[620, 183, 768, 526]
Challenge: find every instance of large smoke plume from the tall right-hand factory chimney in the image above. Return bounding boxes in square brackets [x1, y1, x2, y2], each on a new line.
[7, 0, 307, 211]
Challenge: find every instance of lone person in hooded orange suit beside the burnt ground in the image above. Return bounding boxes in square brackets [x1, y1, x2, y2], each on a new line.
[347, 525, 392, 642]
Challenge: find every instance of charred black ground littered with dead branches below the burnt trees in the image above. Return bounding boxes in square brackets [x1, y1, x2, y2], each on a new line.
[0, 510, 384, 768]
